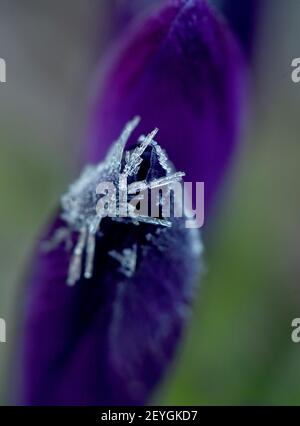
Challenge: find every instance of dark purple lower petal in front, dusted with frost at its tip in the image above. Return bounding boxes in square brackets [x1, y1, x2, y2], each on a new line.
[21, 136, 201, 405]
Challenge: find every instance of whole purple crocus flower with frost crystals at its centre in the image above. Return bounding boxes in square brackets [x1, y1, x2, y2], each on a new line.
[21, 0, 244, 405]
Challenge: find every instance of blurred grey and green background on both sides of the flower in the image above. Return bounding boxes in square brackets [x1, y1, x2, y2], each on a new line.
[0, 0, 300, 405]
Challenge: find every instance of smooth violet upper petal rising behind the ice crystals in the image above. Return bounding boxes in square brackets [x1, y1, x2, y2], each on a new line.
[88, 0, 245, 209]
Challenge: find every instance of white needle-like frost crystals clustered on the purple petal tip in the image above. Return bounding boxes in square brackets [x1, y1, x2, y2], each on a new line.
[44, 117, 200, 285]
